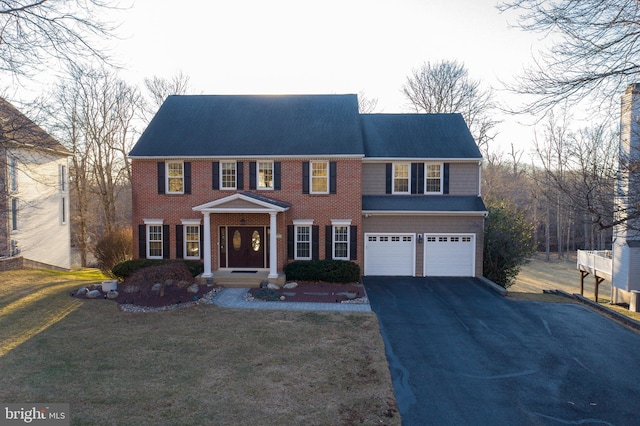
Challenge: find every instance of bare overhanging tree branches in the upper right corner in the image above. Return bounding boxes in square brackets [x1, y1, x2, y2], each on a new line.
[498, 0, 640, 113]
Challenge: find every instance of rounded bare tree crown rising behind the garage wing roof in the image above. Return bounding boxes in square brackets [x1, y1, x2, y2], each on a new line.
[402, 61, 498, 156]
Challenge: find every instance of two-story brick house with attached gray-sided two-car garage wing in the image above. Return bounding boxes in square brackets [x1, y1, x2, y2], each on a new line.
[130, 95, 486, 280]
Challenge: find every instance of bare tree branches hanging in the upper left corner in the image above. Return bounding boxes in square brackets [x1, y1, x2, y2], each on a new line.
[0, 0, 116, 76]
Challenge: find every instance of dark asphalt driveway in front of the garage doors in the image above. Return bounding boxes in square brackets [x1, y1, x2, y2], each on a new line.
[364, 277, 640, 425]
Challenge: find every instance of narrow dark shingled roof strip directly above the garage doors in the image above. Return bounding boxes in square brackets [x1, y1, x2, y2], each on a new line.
[362, 195, 487, 213]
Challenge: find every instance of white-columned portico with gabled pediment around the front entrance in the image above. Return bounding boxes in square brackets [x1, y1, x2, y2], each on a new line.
[193, 192, 290, 279]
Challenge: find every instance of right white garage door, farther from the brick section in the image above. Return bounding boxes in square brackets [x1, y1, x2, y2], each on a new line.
[424, 234, 476, 277]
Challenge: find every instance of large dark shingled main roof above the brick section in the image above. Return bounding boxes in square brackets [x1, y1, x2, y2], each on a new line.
[129, 95, 364, 157]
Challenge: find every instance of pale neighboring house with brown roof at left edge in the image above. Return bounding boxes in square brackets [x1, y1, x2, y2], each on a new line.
[0, 98, 71, 269]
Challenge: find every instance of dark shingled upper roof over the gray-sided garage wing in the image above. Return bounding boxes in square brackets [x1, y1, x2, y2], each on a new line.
[361, 114, 482, 159]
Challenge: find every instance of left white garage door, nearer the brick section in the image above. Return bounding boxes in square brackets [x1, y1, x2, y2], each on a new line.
[364, 234, 416, 276]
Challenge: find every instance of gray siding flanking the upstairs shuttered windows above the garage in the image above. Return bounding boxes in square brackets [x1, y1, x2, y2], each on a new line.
[362, 162, 480, 195]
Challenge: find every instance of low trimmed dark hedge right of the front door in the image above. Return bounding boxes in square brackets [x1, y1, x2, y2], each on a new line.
[284, 260, 360, 283]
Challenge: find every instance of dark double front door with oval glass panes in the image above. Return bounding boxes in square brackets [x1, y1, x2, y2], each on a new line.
[227, 226, 266, 268]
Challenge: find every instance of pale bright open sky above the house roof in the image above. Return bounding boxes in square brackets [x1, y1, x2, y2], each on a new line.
[12, 0, 552, 156]
